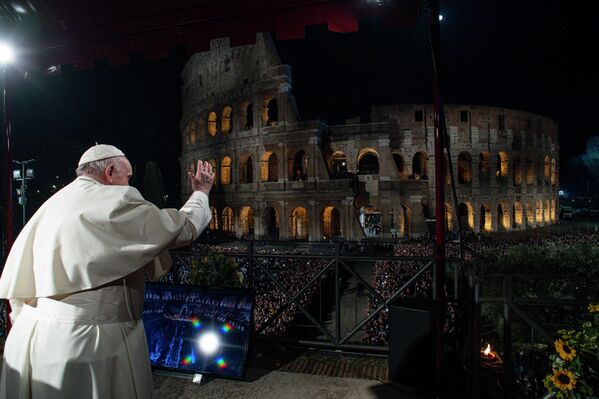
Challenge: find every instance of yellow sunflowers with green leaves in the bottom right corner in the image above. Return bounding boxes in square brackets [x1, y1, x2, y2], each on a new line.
[543, 304, 599, 399]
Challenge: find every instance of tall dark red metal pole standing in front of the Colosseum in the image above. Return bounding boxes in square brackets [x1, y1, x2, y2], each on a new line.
[428, 1, 445, 395]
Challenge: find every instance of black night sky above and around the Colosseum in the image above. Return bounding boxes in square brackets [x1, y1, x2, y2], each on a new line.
[5, 0, 599, 214]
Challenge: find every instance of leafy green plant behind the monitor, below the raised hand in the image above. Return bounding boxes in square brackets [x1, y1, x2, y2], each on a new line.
[190, 251, 243, 287]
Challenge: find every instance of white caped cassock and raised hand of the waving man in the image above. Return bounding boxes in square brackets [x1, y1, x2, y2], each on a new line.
[0, 176, 211, 399]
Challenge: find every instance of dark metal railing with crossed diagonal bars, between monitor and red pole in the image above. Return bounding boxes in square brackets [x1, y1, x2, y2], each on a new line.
[169, 241, 462, 353]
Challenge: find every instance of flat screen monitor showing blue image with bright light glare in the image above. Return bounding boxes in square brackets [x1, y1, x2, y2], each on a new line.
[143, 283, 254, 378]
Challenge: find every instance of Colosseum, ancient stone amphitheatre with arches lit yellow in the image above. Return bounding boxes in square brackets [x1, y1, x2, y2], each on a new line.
[180, 34, 559, 241]
